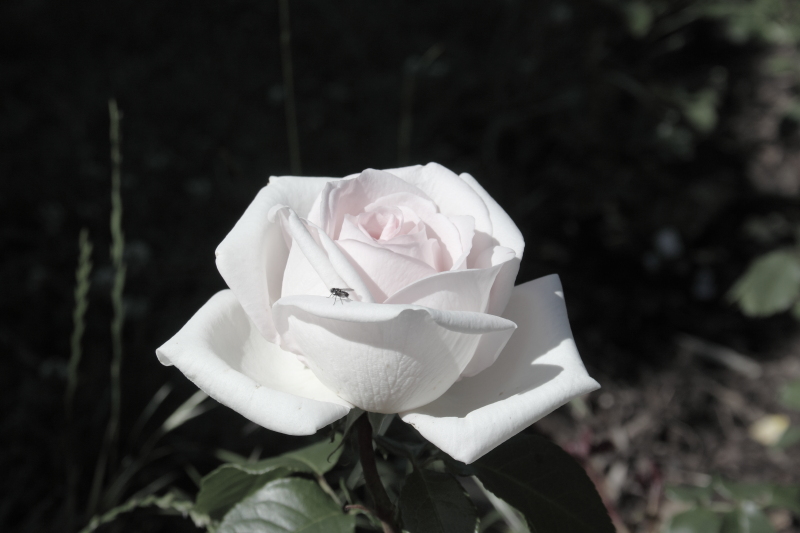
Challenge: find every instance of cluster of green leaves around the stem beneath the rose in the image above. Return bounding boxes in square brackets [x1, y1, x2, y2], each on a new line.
[81, 428, 613, 533]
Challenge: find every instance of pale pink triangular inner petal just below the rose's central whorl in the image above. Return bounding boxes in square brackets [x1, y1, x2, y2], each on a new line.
[337, 239, 436, 302]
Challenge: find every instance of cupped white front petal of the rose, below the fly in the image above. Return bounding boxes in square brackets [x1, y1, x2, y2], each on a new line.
[273, 296, 516, 413]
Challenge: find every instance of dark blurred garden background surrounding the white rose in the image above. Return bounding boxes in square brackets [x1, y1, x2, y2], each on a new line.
[0, 0, 800, 532]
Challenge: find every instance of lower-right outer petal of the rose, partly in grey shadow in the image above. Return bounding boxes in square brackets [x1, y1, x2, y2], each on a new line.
[401, 275, 600, 463]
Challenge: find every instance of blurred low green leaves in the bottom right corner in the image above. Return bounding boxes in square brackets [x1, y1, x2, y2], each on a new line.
[664, 479, 800, 533]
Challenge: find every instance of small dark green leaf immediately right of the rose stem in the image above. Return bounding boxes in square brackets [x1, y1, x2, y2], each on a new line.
[400, 469, 478, 533]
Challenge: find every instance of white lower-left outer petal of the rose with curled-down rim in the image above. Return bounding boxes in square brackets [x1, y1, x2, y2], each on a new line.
[156, 290, 351, 435]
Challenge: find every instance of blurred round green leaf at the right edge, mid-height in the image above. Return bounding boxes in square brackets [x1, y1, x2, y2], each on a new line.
[728, 249, 800, 316]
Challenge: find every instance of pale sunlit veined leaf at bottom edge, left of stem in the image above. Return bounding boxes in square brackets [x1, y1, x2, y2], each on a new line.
[217, 478, 356, 533]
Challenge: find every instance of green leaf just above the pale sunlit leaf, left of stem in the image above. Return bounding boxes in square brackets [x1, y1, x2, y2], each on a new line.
[195, 435, 342, 520]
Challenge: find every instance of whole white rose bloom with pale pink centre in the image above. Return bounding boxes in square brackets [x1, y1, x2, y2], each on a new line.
[156, 163, 599, 463]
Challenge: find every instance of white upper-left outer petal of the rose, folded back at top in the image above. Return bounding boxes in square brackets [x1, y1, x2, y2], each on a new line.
[216, 176, 331, 341]
